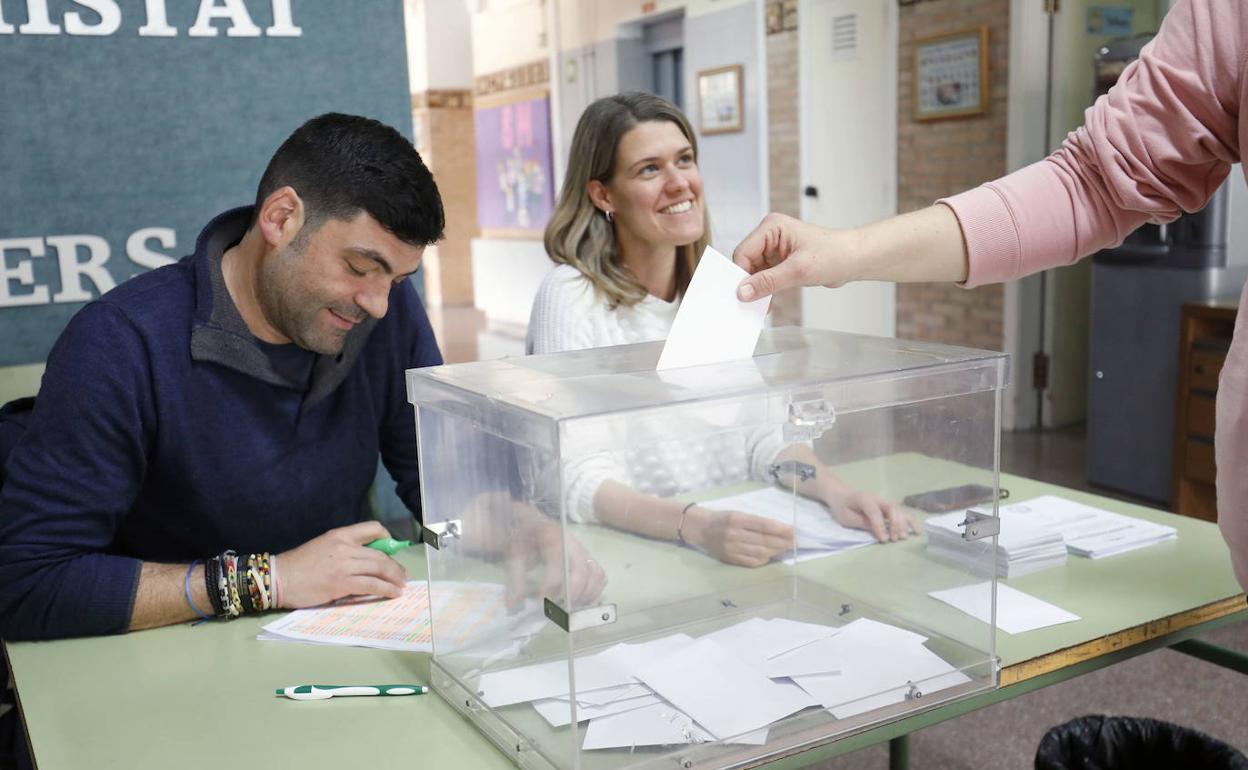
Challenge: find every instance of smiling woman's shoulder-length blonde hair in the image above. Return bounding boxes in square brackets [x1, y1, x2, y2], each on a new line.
[545, 91, 710, 309]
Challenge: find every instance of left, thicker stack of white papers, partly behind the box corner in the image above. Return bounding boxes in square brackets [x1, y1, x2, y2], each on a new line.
[924, 505, 1066, 578]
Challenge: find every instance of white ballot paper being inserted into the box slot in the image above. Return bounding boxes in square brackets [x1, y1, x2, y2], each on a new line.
[655, 246, 771, 371]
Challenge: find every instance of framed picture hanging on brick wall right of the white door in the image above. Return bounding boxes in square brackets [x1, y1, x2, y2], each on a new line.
[914, 26, 988, 120]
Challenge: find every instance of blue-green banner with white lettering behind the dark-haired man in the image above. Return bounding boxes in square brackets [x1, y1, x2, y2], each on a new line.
[0, 0, 412, 366]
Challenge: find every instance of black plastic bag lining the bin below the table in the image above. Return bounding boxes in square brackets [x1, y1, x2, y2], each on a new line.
[1036, 716, 1248, 770]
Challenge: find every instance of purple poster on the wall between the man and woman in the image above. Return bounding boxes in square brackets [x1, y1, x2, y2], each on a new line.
[474, 96, 554, 230]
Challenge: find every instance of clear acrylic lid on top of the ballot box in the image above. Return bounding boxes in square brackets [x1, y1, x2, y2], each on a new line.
[408, 327, 1006, 448]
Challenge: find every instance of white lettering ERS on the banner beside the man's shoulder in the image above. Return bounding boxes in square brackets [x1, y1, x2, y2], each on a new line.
[0, 227, 177, 308]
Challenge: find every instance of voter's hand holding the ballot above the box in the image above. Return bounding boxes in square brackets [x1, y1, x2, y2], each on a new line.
[733, 213, 850, 302]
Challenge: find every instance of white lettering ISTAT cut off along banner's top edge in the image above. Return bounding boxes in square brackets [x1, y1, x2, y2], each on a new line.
[0, 0, 303, 37]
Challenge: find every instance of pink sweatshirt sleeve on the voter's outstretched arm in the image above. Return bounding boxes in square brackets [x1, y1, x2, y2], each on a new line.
[940, 0, 1248, 286]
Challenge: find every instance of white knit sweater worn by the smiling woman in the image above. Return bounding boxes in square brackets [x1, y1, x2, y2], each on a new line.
[525, 265, 784, 522]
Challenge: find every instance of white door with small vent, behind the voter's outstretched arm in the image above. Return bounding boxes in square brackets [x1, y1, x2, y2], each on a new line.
[799, 0, 897, 337]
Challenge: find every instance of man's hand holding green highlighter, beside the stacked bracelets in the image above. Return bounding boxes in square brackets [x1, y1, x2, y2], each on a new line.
[277, 522, 407, 609]
